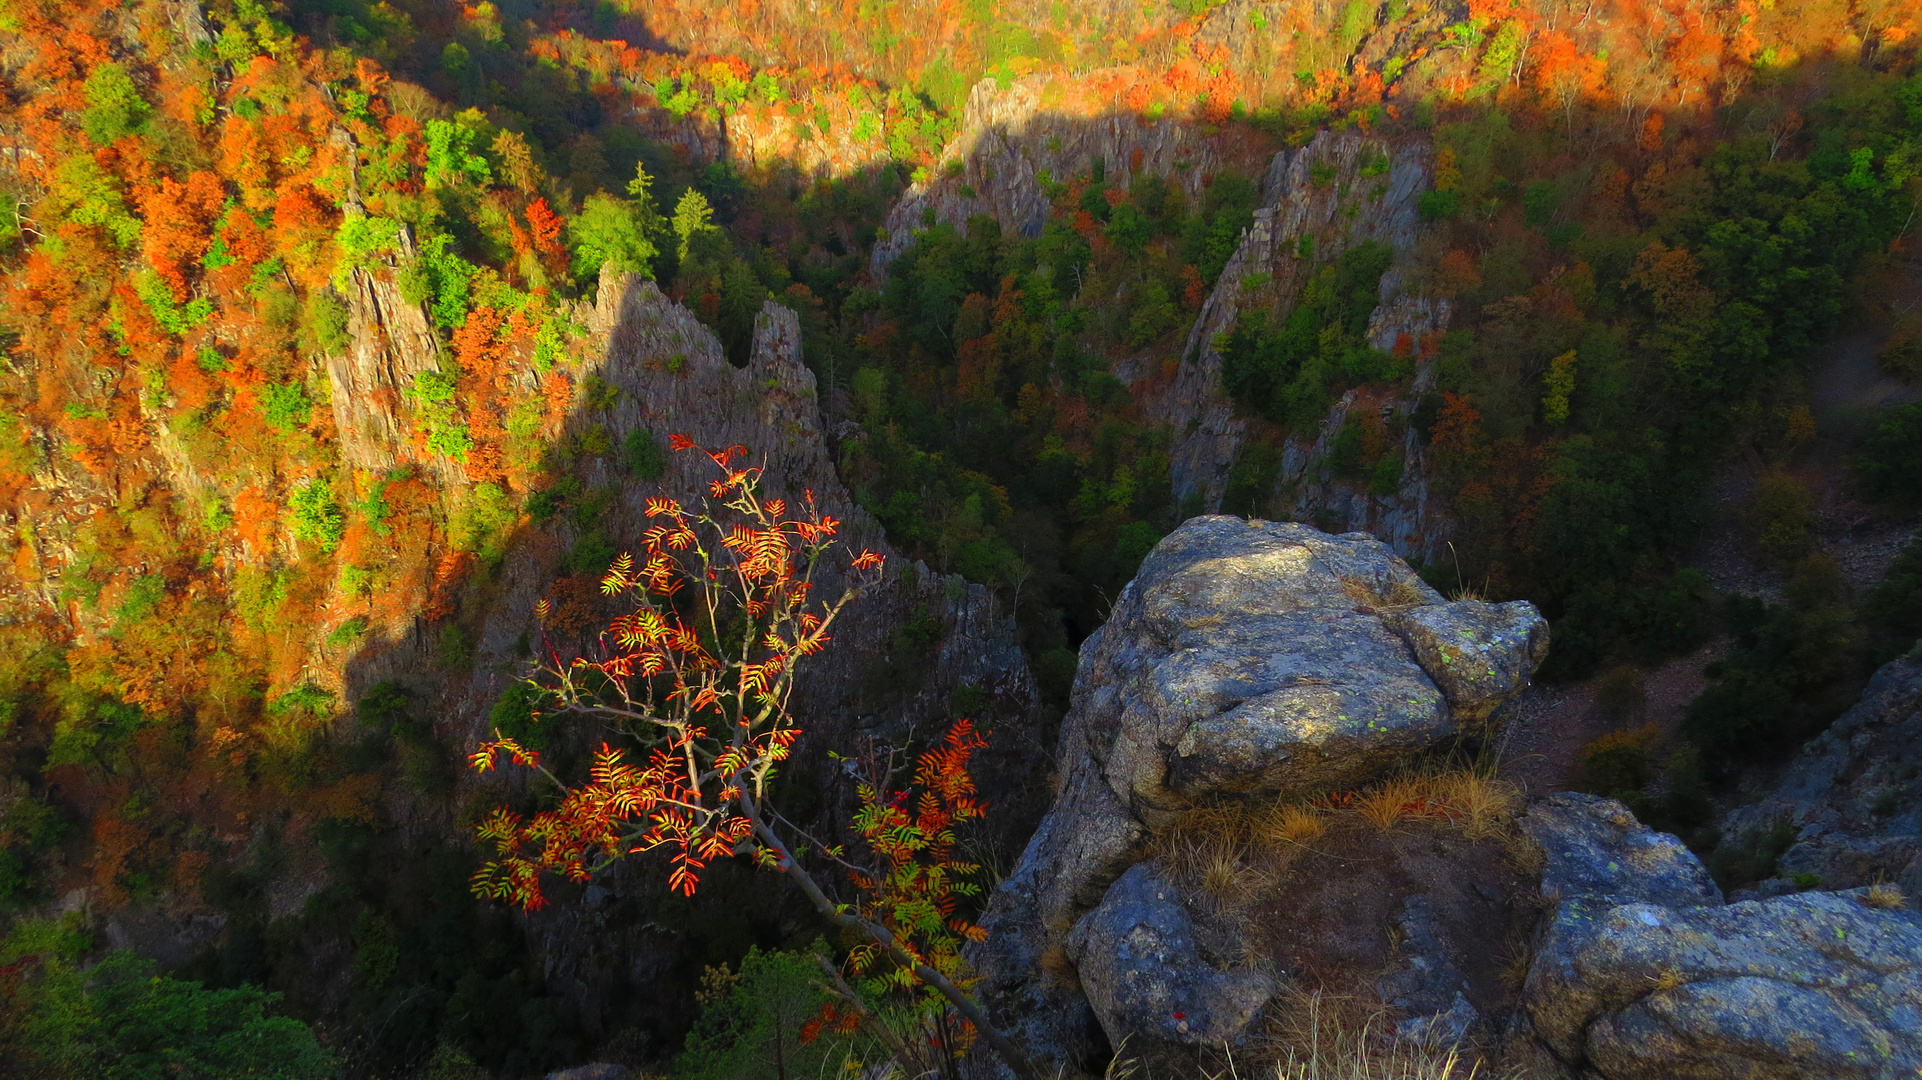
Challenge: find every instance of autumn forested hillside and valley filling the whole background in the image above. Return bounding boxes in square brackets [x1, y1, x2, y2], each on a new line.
[0, 0, 1922, 1076]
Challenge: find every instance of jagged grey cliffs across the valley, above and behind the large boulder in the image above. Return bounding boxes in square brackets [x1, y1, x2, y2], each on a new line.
[871, 84, 1451, 557]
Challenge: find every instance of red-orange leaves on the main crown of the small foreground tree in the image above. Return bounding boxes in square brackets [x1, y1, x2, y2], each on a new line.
[469, 434, 880, 909]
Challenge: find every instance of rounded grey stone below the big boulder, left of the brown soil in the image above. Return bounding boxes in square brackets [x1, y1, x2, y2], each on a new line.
[1069, 863, 1276, 1047]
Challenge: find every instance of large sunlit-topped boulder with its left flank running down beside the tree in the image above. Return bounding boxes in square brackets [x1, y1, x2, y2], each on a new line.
[976, 517, 1547, 1061]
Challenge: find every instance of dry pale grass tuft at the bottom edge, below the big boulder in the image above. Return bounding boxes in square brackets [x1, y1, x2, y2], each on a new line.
[1272, 992, 1482, 1080]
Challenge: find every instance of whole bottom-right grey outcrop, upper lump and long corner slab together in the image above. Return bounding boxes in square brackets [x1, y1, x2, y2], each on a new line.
[1524, 794, 1922, 1080]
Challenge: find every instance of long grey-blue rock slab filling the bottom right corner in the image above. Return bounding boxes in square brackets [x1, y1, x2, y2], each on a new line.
[1526, 892, 1922, 1080]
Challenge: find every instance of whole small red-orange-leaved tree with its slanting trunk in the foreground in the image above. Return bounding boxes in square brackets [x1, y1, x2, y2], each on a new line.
[471, 434, 1032, 1076]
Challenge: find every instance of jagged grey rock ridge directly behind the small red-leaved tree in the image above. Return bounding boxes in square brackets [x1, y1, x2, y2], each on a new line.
[424, 273, 1040, 1015]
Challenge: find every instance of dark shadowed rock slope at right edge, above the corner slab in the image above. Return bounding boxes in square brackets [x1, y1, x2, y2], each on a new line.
[1724, 653, 1922, 896]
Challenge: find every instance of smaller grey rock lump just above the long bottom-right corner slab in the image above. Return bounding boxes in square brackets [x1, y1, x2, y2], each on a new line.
[1522, 792, 1722, 907]
